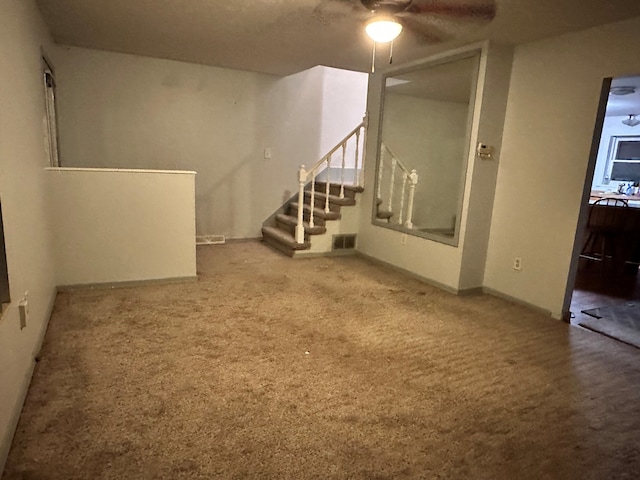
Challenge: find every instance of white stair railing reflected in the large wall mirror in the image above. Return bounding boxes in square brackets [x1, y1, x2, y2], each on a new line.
[377, 143, 418, 228]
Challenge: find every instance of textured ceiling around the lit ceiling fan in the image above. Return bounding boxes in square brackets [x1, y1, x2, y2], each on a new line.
[36, 0, 640, 75]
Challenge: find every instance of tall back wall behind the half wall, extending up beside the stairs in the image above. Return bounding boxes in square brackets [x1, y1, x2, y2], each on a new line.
[56, 48, 364, 238]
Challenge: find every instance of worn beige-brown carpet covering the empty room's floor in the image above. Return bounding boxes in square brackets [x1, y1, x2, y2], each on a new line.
[3, 243, 640, 480]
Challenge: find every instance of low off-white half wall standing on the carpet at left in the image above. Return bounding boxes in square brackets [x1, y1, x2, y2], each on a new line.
[47, 168, 196, 285]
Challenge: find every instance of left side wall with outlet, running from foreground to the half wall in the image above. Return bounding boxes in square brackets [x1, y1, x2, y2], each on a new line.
[0, 0, 55, 471]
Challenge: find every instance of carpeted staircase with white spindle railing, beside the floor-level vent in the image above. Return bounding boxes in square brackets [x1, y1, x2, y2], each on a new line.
[262, 115, 367, 257]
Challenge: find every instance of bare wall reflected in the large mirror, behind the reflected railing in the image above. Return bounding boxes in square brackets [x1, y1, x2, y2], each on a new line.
[381, 94, 469, 228]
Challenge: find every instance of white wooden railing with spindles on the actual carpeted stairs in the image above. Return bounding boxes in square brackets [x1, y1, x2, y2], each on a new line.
[296, 114, 368, 243]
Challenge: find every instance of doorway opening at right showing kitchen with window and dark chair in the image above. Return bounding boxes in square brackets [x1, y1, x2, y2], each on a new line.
[565, 75, 640, 348]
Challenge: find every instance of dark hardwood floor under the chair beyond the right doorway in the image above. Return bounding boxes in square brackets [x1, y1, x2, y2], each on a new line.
[571, 260, 640, 330]
